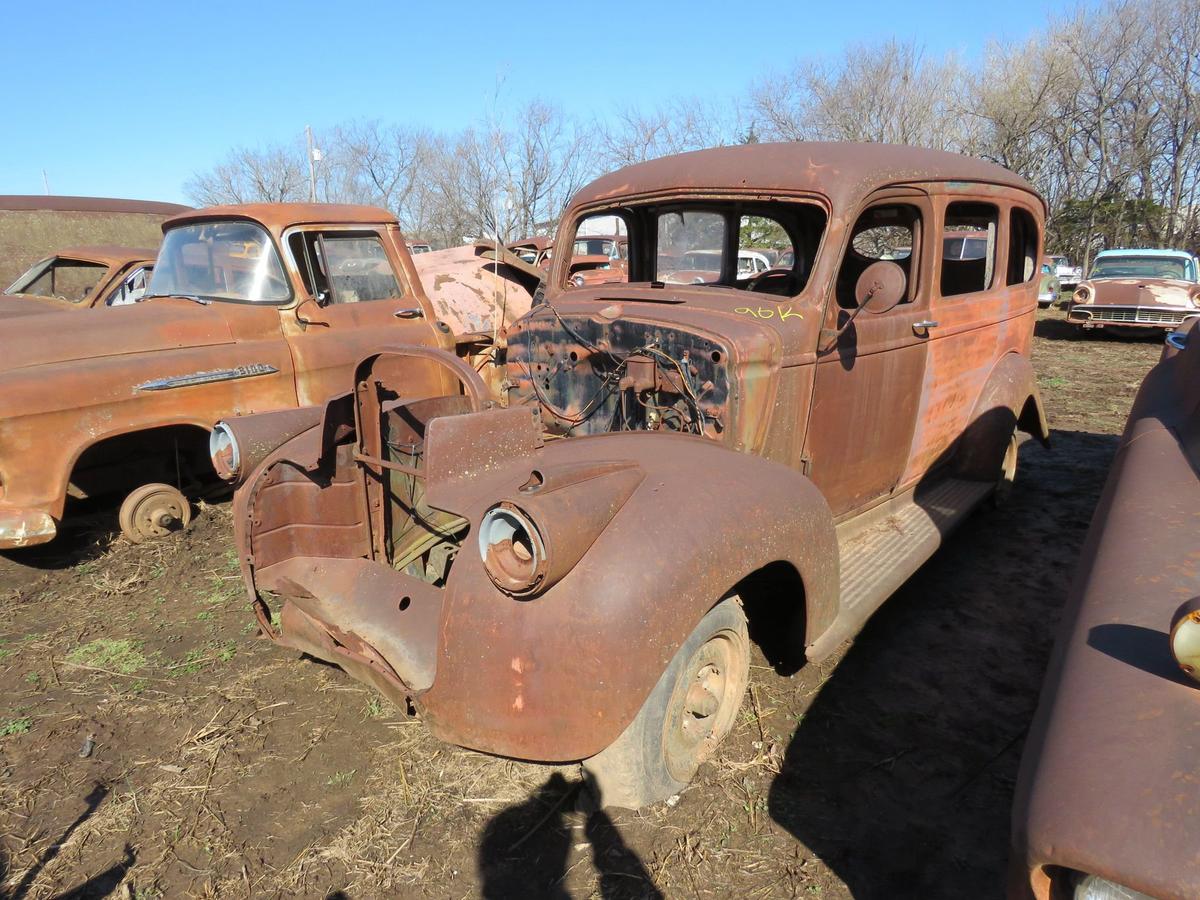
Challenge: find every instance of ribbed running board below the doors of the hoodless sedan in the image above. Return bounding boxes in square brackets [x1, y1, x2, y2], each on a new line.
[805, 478, 994, 660]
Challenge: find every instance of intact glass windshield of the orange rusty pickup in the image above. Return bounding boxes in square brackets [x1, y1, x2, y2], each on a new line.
[146, 222, 292, 304]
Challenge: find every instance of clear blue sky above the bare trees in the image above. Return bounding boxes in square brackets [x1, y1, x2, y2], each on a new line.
[0, 0, 1094, 200]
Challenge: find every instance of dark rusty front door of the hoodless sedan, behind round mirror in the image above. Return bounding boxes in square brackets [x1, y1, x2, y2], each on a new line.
[804, 190, 932, 517]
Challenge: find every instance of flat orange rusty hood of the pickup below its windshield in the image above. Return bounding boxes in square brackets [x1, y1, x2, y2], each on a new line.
[0, 299, 233, 371]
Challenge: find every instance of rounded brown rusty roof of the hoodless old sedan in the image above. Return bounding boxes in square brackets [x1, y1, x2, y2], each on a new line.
[571, 142, 1038, 208]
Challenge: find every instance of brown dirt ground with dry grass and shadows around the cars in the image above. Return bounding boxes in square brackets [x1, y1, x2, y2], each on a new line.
[0, 310, 1159, 900]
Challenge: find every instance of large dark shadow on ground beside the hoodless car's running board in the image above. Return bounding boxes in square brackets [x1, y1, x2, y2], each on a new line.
[769, 432, 1117, 898]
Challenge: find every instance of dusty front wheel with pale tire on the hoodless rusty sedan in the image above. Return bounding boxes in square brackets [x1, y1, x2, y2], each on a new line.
[583, 596, 750, 809]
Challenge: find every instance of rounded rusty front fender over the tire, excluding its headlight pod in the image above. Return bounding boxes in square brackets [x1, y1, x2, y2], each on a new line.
[418, 429, 838, 761]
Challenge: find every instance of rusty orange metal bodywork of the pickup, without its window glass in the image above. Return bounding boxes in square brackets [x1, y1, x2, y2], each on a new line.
[0, 204, 501, 547]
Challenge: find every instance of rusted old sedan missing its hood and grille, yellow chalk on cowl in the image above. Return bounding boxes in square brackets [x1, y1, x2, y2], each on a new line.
[223, 143, 1048, 806]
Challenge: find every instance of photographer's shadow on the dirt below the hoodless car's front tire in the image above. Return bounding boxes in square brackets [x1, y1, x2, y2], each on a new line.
[479, 773, 662, 900]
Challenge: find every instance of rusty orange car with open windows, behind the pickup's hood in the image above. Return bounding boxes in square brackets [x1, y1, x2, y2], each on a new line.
[0, 247, 155, 317]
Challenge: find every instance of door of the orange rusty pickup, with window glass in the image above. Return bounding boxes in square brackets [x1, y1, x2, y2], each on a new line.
[283, 227, 434, 406]
